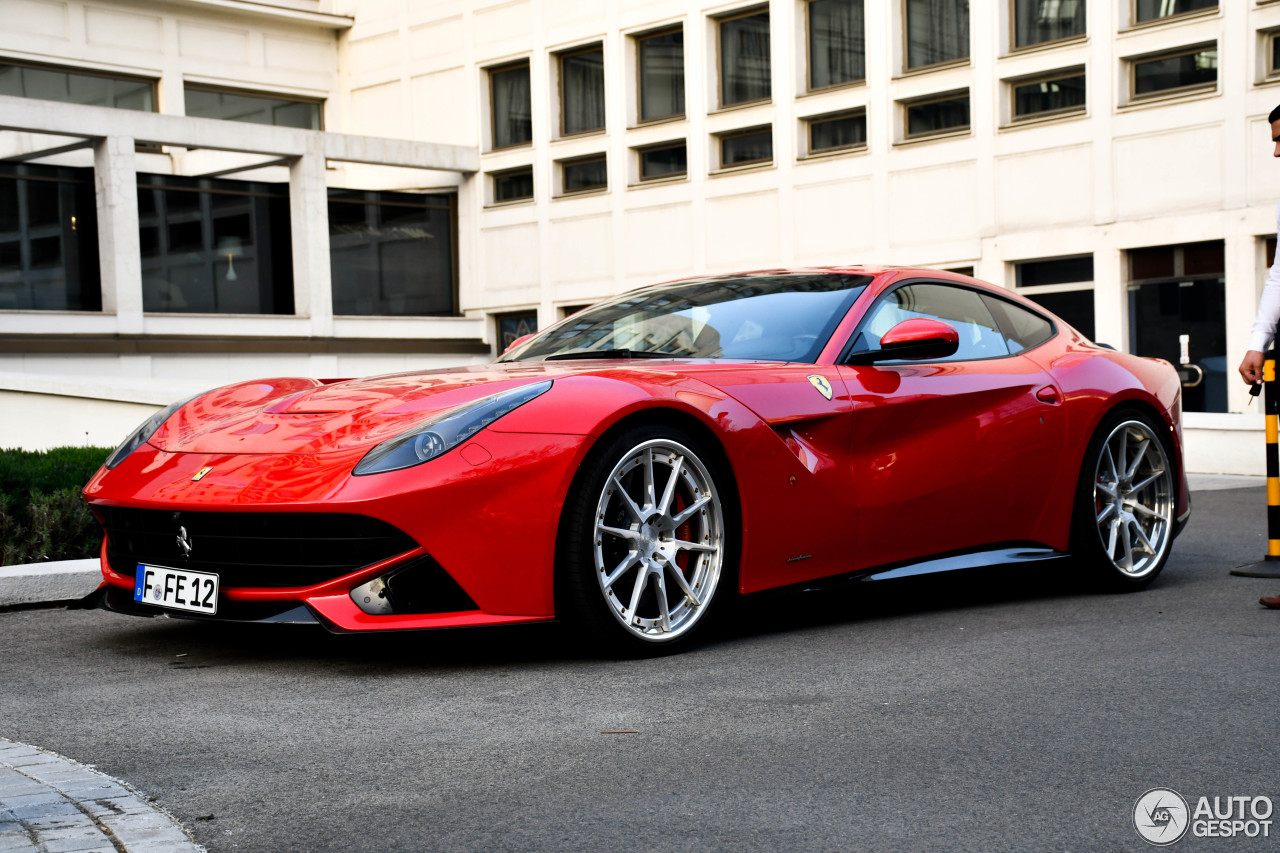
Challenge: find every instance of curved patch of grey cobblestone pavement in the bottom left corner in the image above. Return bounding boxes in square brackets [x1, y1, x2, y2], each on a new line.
[0, 738, 204, 853]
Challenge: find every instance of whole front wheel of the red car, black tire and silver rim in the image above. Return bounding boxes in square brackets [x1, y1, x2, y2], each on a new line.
[561, 425, 736, 656]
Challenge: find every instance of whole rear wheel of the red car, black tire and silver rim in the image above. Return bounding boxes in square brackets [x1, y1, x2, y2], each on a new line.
[1071, 410, 1178, 590]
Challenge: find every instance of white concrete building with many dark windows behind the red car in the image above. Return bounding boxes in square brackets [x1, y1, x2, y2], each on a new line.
[0, 0, 1280, 473]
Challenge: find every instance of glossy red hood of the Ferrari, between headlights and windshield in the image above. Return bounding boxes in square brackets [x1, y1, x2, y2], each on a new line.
[150, 360, 757, 453]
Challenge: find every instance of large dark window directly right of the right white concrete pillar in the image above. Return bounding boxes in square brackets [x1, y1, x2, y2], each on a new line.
[329, 190, 457, 316]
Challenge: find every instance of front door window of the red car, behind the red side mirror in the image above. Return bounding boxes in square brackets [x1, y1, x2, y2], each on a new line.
[854, 284, 1009, 361]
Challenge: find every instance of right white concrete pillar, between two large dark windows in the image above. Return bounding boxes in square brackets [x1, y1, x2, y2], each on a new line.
[289, 133, 333, 338]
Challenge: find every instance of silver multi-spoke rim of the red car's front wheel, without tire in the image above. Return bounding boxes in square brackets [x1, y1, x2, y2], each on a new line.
[593, 438, 724, 642]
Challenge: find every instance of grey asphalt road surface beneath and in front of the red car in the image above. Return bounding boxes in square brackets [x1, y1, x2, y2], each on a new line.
[0, 488, 1280, 852]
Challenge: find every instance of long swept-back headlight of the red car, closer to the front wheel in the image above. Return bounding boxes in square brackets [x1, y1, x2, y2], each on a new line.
[352, 379, 552, 475]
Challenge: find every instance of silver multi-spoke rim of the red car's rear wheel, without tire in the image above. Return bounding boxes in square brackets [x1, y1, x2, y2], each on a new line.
[1093, 420, 1174, 578]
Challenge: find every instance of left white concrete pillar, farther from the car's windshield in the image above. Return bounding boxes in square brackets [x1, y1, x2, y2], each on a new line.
[93, 136, 142, 334]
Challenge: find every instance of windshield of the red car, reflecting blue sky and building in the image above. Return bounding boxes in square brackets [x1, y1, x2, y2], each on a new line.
[500, 273, 872, 362]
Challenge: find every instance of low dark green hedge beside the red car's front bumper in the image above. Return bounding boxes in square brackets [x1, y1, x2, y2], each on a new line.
[0, 447, 111, 566]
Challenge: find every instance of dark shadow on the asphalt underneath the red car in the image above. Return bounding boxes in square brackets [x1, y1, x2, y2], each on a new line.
[85, 558, 1146, 670]
